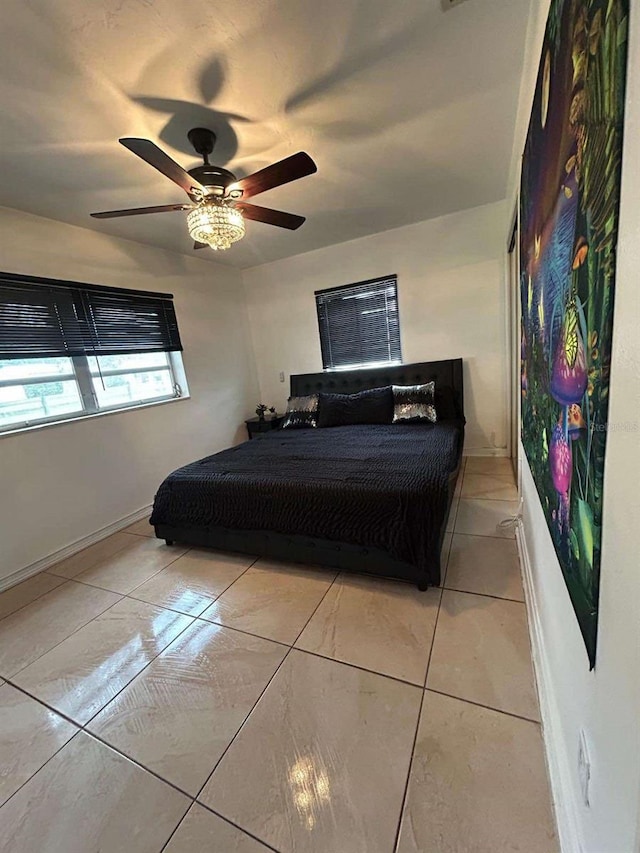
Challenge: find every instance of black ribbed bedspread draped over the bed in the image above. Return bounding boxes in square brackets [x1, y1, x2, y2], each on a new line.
[151, 421, 462, 584]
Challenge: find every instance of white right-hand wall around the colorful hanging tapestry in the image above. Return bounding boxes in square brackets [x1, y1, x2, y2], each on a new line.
[505, 0, 640, 853]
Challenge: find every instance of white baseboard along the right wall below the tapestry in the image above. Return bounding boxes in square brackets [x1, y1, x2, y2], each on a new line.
[516, 519, 582, 853]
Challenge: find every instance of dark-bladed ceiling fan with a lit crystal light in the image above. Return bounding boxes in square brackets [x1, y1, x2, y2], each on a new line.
[91, 127, 318, 251]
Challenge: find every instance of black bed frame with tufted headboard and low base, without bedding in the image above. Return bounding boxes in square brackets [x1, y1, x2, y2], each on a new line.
[155, 358, 464, 590]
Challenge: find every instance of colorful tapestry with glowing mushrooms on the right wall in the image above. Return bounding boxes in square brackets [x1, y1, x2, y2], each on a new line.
[520, 0, 628, 667]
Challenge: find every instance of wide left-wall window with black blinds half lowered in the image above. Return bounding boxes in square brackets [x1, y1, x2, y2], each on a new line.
[0, 273, 185, 432]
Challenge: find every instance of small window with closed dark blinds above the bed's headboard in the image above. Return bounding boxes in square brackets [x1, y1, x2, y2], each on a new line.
[315, 275, 402, 370]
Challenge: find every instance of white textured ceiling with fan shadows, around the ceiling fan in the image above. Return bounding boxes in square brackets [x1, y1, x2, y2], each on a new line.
[0, 0, 529, 267]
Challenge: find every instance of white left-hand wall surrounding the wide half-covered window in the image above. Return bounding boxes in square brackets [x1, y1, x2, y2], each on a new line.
[0, 208, 258, 582]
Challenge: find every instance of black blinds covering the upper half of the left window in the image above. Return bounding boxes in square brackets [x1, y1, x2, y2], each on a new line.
[0, 273, 182, 359]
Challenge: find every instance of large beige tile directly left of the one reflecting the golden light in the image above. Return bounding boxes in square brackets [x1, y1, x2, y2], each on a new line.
[89, 620, 287, 796]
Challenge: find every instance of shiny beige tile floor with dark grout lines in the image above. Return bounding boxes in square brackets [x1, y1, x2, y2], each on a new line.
[0, 458, 557, 853]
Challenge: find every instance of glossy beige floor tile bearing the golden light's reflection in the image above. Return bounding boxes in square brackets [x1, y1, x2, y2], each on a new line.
[198, 650, 422, 853]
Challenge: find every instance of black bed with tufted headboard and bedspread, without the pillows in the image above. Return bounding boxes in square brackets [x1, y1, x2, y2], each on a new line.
[151, 359, 464, 589]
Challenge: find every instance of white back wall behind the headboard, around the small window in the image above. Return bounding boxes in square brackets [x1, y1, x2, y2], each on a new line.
[243, 202, 508, 453]
